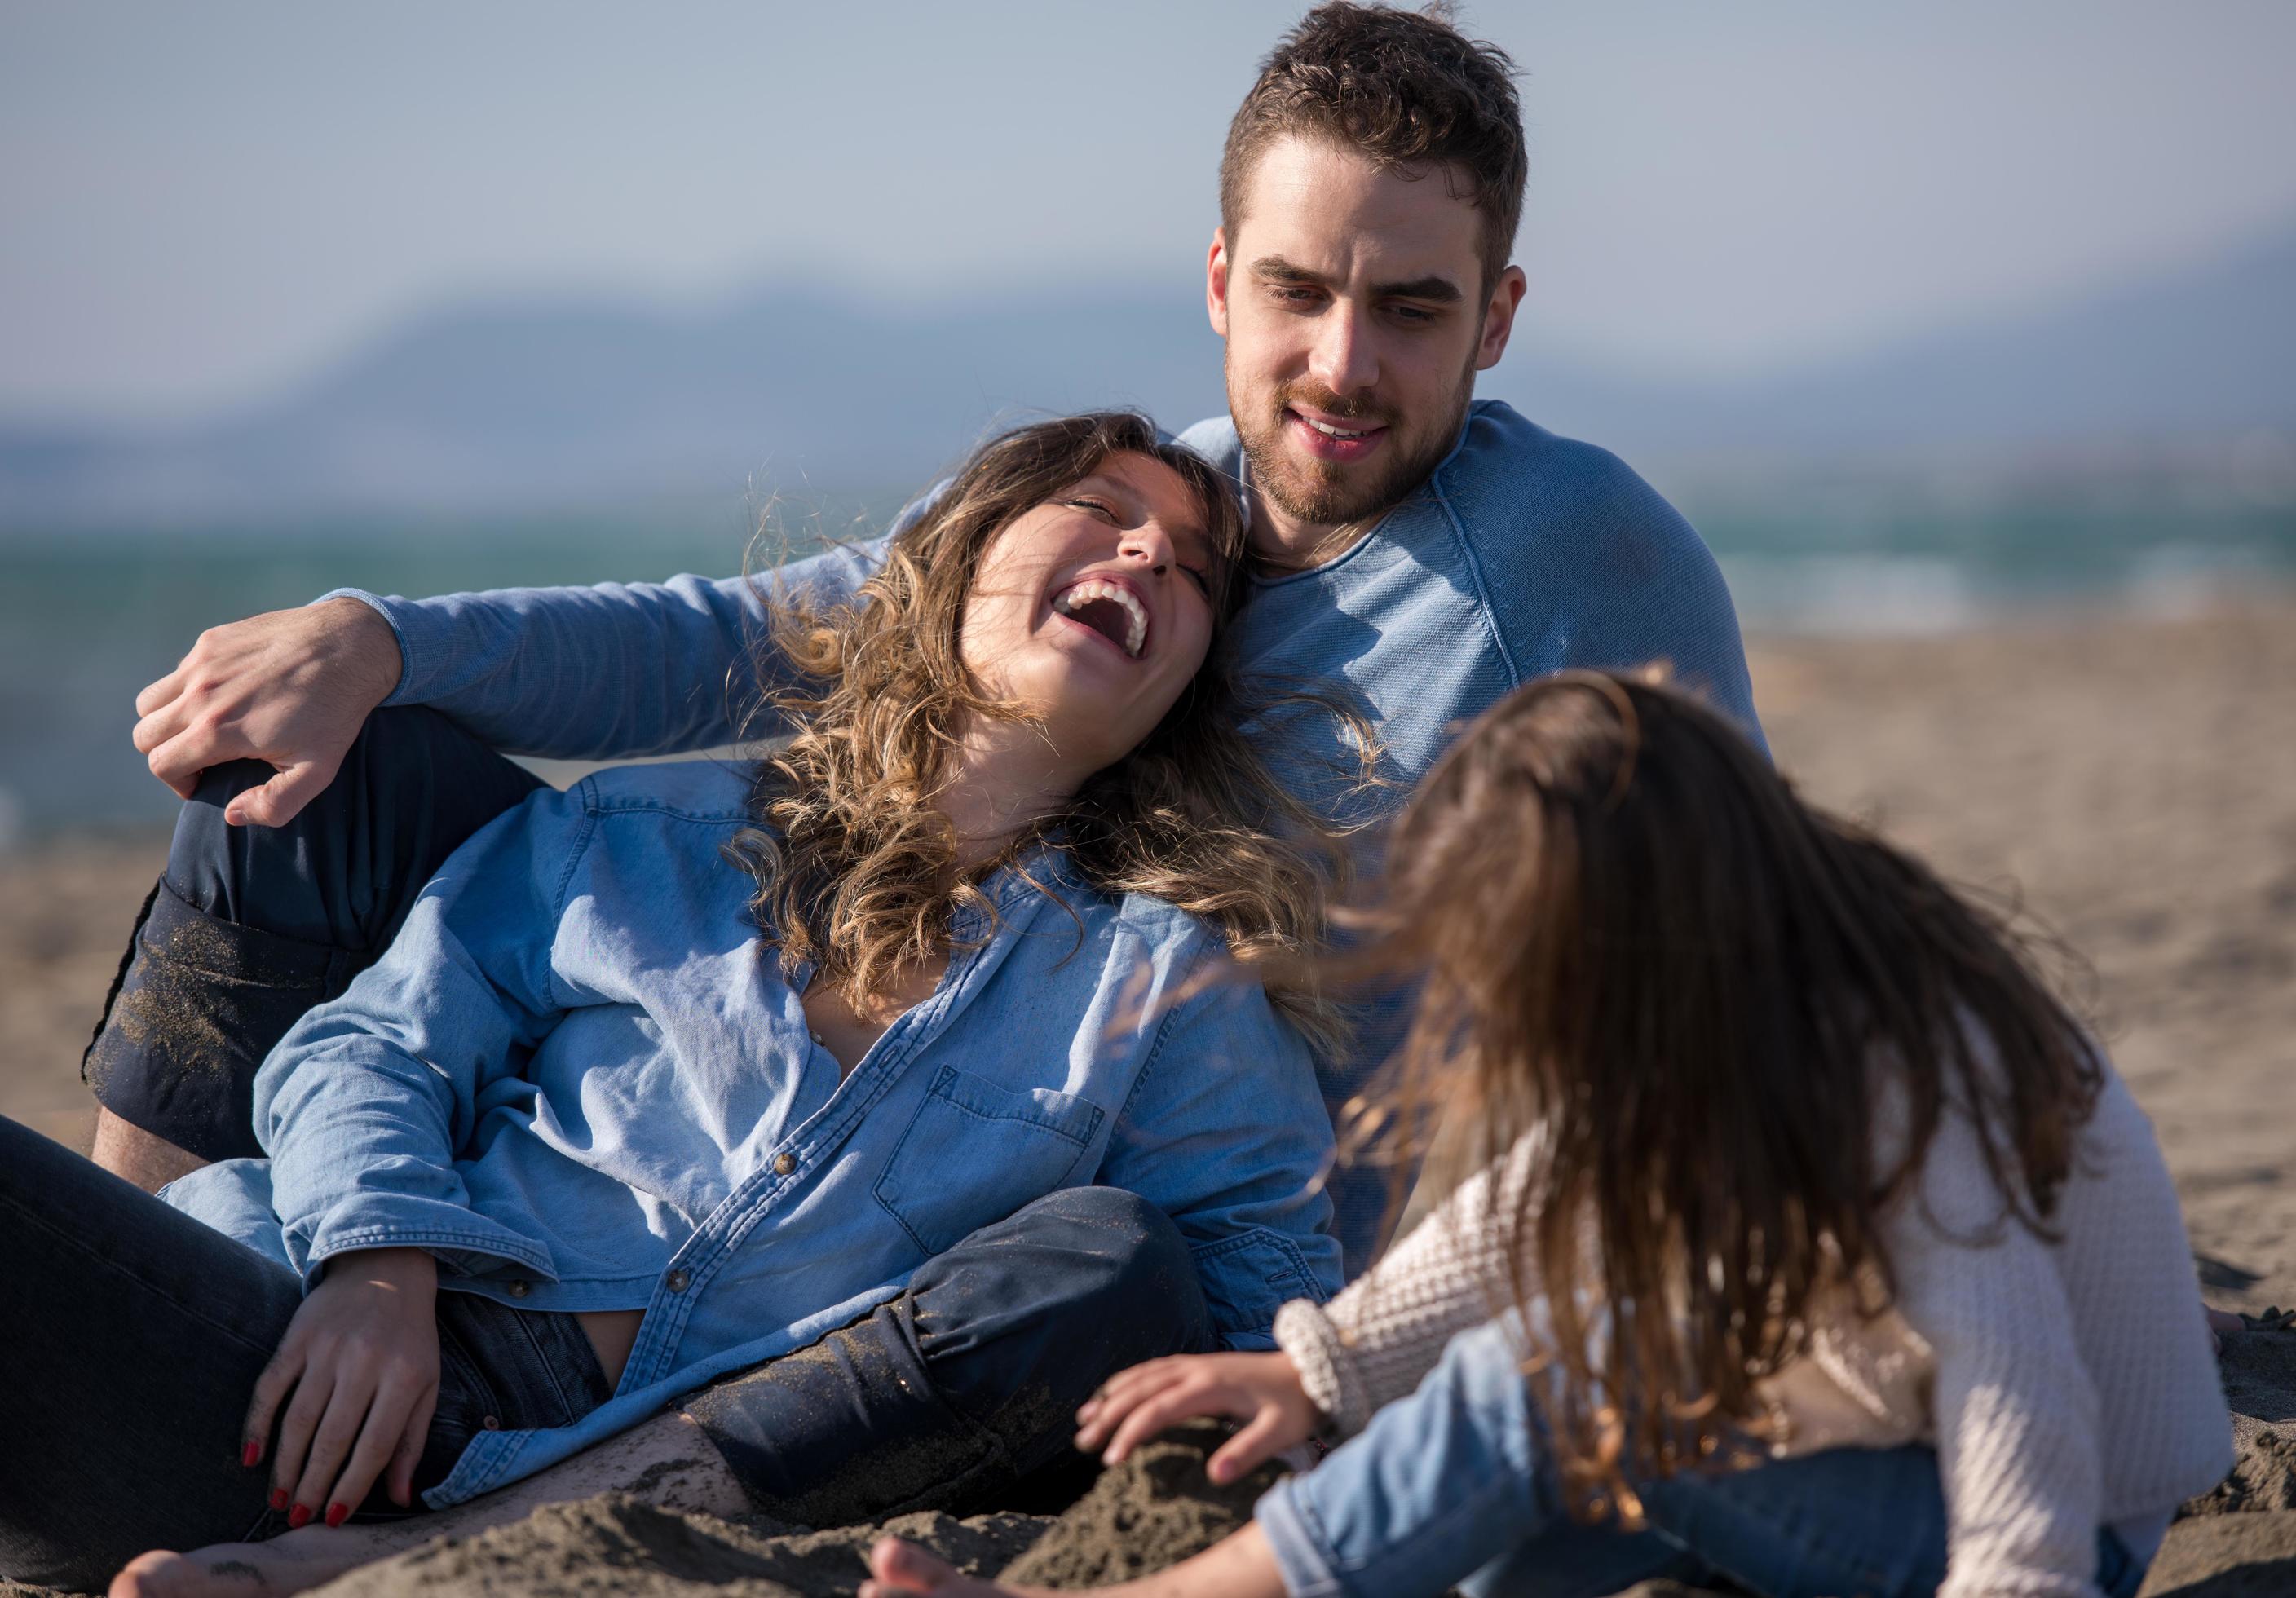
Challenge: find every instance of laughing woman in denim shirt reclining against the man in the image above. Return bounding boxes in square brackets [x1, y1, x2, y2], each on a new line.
[0, 416, 1339, 1584]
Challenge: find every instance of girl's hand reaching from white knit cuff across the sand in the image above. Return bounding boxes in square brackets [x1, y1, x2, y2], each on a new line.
[1077, 1354, 1322, 1483]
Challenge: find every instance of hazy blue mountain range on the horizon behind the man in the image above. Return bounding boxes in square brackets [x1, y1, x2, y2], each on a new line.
[0, 230, 2296, 531]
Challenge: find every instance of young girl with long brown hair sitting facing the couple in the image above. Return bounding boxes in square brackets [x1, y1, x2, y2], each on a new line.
[866, 673, 2229, 1598]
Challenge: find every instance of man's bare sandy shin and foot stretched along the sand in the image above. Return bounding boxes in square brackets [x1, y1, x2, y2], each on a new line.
[113, 1415, 751, 1598]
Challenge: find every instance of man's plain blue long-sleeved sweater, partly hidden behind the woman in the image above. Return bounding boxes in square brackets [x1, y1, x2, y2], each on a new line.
[331, 400, 1761, 1274]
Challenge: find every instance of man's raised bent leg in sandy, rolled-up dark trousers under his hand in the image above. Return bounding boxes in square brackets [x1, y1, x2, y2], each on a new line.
[81, 707, 540, 1190]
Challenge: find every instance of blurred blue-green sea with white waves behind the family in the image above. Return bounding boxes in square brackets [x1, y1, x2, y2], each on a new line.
[0, 484, 2296, 850]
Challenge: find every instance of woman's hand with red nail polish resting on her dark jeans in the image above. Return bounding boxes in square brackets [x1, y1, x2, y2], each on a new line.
[241, 1249, 439, 1527]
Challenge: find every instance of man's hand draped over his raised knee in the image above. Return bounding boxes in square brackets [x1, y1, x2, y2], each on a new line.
[135, 599, 400, 827]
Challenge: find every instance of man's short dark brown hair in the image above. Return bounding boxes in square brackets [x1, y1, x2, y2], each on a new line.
[1219, 0, 1529, 294]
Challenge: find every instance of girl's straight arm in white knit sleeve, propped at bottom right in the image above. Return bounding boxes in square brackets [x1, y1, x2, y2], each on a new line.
[1888, 1109, 2103, 1598]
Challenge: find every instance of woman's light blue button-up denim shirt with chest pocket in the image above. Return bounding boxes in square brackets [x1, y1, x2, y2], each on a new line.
[166, 762, 1341, 1506]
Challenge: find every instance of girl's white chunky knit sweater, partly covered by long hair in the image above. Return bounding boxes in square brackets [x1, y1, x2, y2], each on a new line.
[1277, 1067, 2232, 1598]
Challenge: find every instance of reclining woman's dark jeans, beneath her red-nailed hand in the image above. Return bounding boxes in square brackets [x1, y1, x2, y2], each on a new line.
[0, 1118, 611, 1589]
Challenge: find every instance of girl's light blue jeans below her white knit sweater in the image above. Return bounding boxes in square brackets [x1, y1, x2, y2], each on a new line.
[1256, 1320, 2144, 1598]
